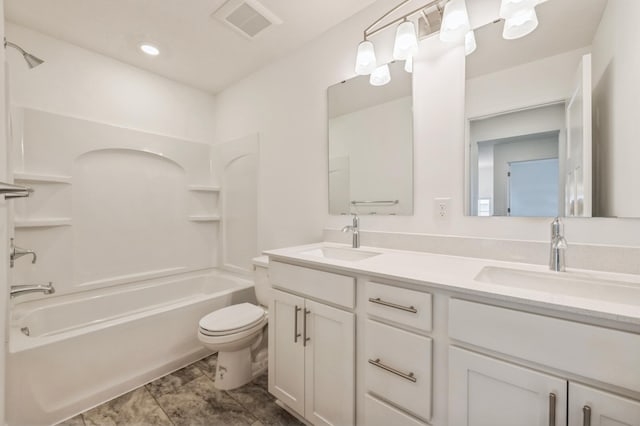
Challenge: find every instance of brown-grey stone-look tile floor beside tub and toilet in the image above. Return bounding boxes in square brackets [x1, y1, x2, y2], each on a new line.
[59, 355, 302, 426]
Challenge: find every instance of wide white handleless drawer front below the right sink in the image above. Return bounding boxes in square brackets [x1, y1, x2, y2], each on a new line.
[449, 299, 640, 392]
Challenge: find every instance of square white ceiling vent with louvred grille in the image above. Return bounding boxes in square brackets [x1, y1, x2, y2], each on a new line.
[211, 0, 282, 40]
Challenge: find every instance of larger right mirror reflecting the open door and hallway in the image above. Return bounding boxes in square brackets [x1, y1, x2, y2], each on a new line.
[465, 0, 640, 217]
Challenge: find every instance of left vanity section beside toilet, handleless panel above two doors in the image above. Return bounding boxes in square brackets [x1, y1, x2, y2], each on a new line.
[269, 261, 355, 425]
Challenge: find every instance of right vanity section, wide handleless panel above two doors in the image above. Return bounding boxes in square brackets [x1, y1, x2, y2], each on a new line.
[449, 299, 640, 426]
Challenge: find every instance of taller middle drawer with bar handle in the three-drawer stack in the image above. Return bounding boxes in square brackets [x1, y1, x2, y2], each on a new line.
[365, 320, 431, 420]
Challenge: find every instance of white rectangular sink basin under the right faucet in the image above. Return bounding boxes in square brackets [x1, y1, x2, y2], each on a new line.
[475, 266, 640, 305]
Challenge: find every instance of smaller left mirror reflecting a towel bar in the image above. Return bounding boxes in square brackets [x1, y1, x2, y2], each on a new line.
[327, 63, 413, 215]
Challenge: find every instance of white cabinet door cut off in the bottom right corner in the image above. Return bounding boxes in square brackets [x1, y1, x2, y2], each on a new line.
[569, 383, 640, 426]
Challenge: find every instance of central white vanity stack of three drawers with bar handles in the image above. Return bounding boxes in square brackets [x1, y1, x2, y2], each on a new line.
[361, 280, 433, 425]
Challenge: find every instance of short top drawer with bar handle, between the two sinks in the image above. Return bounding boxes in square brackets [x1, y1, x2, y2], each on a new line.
[366, 281, 431, 331]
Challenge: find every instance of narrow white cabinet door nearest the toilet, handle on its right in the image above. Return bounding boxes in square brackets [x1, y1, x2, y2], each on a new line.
[269, 290, 304, 414]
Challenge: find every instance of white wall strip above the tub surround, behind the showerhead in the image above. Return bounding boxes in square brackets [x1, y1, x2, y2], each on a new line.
[6, 22, 215, 143]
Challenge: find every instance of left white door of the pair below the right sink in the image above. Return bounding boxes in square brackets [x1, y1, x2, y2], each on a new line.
[449, 347, 567, 426]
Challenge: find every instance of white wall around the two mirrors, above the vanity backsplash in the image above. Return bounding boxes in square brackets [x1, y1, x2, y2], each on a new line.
[216, 0, 640, 249]
